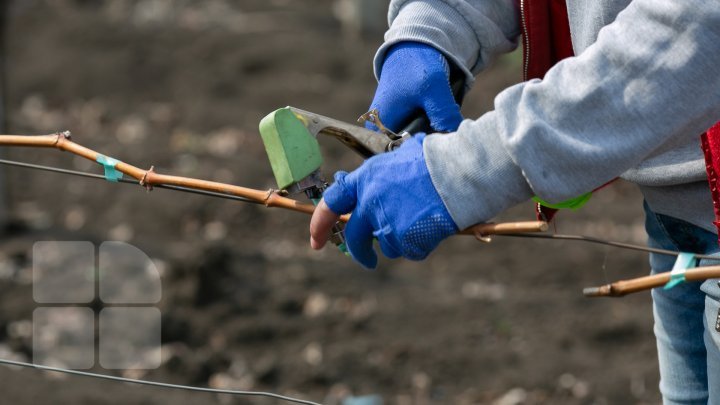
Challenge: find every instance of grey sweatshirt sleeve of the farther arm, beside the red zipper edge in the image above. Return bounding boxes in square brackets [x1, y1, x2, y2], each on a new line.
[374, 0, 520, 87]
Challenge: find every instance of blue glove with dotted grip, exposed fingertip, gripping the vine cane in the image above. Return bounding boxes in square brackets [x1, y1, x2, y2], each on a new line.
[323, 134, 458, 268]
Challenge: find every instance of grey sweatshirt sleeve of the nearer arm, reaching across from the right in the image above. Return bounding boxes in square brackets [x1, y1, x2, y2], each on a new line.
[424, 0, 720, 229]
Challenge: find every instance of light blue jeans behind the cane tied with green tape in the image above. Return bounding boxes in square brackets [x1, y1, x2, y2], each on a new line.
[645, 205, 720, 405]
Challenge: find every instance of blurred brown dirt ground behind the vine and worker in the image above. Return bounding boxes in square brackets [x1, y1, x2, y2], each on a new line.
[0, 0, 659, 405]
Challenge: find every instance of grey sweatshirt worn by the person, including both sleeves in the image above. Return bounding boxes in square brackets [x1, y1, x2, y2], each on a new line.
[375, 0, 720, 232]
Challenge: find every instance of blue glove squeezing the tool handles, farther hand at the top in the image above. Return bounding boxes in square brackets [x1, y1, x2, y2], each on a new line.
[366, 42, 463, 132]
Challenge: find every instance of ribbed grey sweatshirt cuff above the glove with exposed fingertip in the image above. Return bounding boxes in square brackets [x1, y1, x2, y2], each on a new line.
[424, 112, 533, 229]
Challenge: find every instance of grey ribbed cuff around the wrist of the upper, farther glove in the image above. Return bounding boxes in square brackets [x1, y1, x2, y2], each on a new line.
[373, 0, 479, 89]
